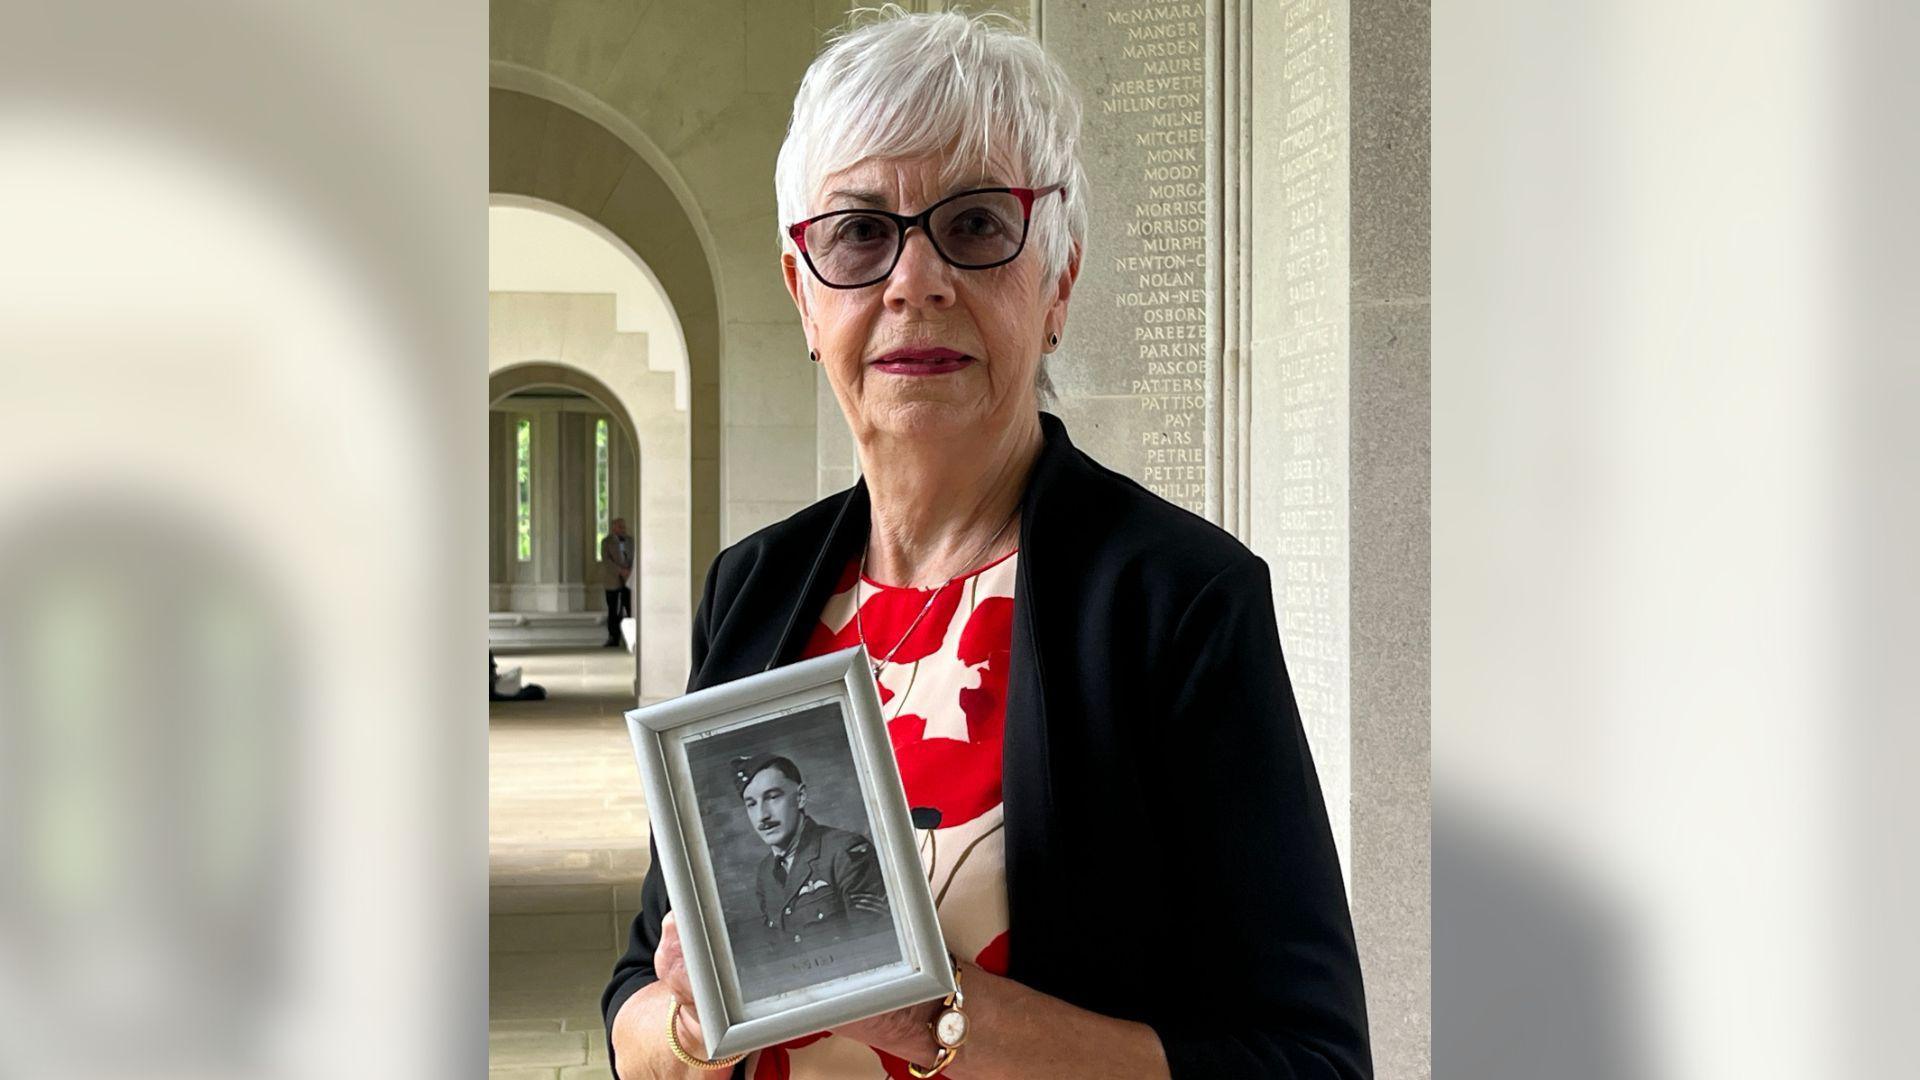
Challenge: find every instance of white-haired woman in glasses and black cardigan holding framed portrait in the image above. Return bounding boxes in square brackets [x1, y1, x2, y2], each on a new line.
[603, 12, 1371, 1080]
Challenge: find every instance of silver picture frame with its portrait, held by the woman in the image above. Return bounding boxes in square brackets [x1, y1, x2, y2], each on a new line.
[626, 646, 954, 1059]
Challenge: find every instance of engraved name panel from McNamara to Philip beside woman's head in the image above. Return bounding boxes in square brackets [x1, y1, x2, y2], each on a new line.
[1039, 2, 1219, 519]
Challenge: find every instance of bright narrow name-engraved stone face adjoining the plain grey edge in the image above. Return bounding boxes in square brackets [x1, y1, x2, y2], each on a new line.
[1244, 0, 1352, 868]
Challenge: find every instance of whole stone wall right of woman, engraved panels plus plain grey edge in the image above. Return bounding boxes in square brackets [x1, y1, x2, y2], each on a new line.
[1033, 0, 1430, 1078]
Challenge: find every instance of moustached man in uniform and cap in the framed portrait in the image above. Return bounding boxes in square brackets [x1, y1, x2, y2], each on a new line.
[733, 753, 889, 947]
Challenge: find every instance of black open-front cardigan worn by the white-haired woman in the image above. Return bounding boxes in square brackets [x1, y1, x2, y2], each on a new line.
[601, 413, 1373, 1080]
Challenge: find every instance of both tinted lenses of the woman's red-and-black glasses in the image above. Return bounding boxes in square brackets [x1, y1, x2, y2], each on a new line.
[806, 192, 1027, 284]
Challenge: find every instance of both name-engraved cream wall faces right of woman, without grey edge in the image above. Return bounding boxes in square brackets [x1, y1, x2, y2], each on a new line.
[1039, 0, 1352, 876]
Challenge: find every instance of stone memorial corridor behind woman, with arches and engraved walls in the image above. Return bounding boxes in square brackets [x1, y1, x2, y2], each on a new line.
[491, 0, 1430, 1080]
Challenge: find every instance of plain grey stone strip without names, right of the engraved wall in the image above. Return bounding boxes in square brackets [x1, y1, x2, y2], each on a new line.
[1348, 0, 1432, 1076]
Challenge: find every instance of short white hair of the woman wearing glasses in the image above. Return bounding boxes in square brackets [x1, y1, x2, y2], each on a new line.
[774, 4, 1087, 388]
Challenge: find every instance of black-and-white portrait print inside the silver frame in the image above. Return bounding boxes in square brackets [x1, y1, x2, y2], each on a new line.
[685, 701, 900, 1003]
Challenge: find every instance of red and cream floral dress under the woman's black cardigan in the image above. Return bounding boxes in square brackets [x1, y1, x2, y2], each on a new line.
[747, 552, 1020, 1080]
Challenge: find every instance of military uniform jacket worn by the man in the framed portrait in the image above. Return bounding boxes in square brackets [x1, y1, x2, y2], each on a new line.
[758, 817, 887, 947]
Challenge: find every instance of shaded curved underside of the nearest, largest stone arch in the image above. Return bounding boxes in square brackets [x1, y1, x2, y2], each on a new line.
[490, 86, 720, 609]
